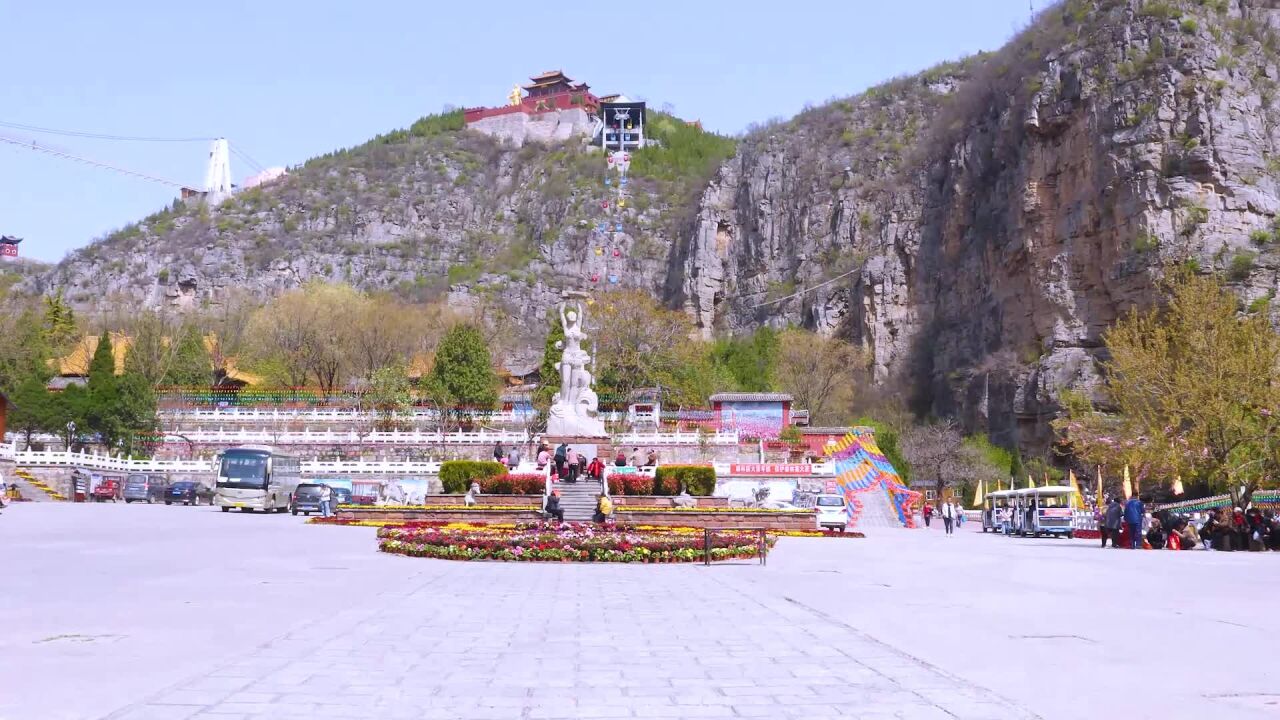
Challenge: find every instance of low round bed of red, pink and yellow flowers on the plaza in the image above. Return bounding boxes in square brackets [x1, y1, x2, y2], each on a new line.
[378, 523, 776, 562]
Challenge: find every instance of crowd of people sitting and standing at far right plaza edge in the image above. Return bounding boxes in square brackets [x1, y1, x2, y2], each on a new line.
[1098, 497, 1280, 552]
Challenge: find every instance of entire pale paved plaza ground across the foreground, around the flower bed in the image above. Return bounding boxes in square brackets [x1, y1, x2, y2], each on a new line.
[0, 503, 1280, 720]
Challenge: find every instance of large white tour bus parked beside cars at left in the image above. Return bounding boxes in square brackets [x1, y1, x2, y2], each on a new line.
[214, 445, 302, 512]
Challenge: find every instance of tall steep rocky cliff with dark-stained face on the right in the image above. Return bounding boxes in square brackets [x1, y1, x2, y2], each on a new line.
[681, 0, 1280, 446]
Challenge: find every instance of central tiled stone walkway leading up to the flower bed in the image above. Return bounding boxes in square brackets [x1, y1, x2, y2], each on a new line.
[113, 561, 1034, 720]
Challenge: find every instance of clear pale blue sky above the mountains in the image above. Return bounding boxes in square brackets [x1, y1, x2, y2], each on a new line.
[0, 0, 1047, 261]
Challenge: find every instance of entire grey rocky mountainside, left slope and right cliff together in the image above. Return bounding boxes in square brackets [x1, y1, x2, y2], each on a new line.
[27, 0, 1280, 446]
